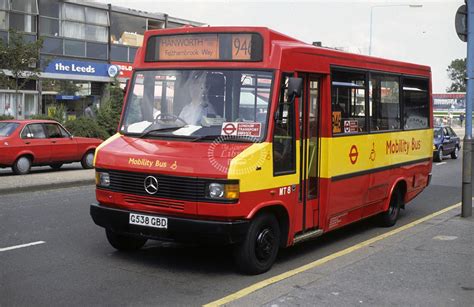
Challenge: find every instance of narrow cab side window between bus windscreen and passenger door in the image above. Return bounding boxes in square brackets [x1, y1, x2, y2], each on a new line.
[273, 75, 296, 175]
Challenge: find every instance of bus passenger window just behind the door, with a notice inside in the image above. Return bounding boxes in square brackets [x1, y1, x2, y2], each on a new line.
[331, 71, 367, 134]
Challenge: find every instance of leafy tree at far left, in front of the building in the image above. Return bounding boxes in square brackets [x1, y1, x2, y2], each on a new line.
[0, 29, 43, 112]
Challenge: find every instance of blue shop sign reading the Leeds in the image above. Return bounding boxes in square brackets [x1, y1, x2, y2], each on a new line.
[44, 59, 118, 77]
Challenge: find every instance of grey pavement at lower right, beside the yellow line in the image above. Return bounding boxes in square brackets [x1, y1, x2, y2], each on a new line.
[221, 206, 474, 307]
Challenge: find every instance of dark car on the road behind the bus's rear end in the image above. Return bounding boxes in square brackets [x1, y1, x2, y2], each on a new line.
[433, 126, 461, 162]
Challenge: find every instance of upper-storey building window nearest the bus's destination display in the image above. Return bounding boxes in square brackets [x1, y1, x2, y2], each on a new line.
[110, 12, 146, 47]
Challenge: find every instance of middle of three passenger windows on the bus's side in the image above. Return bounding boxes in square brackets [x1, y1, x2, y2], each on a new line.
[369, 75, 400, 131]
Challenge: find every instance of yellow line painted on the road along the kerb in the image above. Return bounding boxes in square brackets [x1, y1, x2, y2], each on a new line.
[204, 203, 461, 307]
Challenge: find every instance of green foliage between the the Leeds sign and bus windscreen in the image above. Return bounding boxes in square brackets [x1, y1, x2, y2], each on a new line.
[96, 80, 123, 135]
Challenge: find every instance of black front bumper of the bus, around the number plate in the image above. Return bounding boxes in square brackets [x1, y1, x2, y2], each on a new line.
[90, 204, 250, 245]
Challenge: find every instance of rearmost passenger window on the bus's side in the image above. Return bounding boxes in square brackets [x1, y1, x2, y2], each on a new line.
[403, 78, 430, 129]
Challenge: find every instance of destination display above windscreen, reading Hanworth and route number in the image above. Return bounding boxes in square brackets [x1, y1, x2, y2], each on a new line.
[145, 33, 263, 62]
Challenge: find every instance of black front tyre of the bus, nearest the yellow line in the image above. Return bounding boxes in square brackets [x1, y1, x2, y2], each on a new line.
[234, 213, 280, 275]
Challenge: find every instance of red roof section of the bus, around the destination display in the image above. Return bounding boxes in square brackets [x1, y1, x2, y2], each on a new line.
[134, 26, 431, 76]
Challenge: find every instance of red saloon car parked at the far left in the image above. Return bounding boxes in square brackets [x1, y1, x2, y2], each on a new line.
[0, 120, 102, 175]
